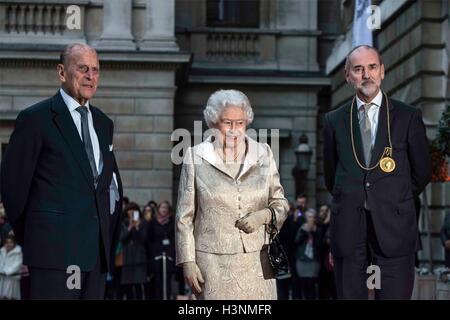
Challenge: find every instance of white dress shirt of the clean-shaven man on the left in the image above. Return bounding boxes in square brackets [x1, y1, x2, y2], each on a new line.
[59, 88, 101, 174]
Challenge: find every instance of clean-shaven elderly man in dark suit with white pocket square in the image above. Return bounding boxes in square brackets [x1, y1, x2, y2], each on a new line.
[1, 44, 122, 299]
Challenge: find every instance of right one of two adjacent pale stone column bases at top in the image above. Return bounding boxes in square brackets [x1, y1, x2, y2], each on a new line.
[140, 0, 179, 51]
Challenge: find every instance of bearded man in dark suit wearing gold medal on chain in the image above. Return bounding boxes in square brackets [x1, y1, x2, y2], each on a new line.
[324, 46, 431, 299]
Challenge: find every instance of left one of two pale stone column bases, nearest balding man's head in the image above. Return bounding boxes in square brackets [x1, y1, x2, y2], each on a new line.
[97, 0, 136, 50]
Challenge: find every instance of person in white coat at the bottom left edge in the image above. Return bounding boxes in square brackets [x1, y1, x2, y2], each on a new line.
[0, 235, 22, 300]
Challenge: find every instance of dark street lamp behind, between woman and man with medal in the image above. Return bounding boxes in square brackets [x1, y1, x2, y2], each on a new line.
[292, 133, 312, 196]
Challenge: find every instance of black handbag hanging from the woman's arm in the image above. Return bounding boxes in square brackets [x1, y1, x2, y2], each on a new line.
[267, 206, 291, 280]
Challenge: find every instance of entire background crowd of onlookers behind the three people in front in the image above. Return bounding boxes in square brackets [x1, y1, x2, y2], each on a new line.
[0, 195, 450, 300]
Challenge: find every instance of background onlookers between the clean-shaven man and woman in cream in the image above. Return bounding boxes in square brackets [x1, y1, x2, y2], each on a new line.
[106, 197, 185, 300]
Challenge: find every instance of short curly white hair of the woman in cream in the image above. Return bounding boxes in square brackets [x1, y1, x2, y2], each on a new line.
[203, 90, 254, 128]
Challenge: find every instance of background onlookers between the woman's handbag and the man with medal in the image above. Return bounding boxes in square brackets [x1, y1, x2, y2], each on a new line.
[277, 194, 336, 300]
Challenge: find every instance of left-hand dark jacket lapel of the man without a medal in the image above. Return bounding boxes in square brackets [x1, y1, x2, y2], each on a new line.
[51, 92, 94, 189]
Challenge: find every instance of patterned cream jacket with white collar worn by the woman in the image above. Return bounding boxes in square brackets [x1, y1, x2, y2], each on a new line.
[175, 136, 289, 264]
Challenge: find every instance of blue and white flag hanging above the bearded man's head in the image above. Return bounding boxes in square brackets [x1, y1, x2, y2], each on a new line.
[352, 0, 373, 48]
